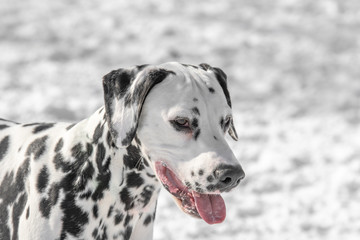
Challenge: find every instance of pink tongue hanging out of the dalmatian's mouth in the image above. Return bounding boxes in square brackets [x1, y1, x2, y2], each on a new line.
[193, 192, 226, 224]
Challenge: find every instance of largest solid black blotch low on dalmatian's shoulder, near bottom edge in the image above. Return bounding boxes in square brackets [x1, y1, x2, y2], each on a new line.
[60, 193, 89, 239]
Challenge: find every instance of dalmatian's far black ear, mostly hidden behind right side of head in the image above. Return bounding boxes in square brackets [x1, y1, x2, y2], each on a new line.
[199, 63, 238, 141]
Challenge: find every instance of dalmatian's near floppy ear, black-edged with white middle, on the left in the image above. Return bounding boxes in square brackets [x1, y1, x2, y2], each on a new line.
[103, 65, 175, 147]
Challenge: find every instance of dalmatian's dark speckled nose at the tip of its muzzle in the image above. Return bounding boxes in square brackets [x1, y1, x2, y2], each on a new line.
[214, 165, 245, 192]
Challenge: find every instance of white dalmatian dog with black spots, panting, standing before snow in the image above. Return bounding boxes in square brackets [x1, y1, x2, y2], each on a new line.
[0, 63, 244, 240]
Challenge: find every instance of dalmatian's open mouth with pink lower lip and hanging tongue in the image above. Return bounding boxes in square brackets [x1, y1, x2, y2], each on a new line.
[155, 162, 226, 224]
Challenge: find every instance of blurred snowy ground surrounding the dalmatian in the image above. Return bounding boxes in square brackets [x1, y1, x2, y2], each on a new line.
[0, 0, 360, 240]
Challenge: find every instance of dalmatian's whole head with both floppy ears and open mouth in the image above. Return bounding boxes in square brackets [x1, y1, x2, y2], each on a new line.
[103, 63, 245, 224]
